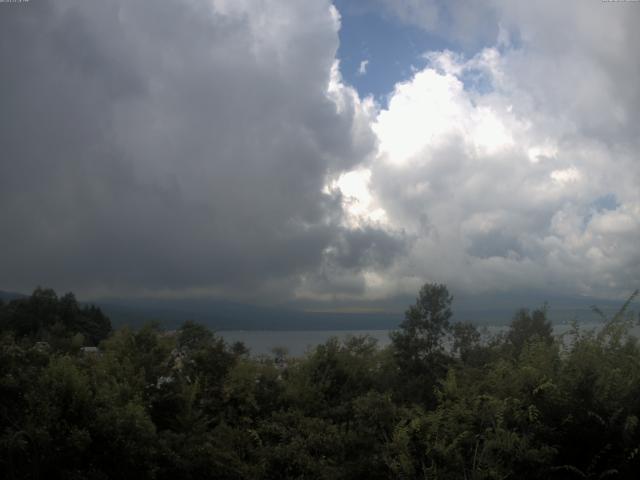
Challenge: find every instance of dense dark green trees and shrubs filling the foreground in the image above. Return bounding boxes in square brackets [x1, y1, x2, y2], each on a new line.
[0, 284, 640, 479]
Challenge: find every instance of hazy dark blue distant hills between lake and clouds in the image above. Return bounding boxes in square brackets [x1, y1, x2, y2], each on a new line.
[0, 291, 636, 331]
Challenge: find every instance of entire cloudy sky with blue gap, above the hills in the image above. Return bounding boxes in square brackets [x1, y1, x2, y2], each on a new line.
[0, 0, 640, 309]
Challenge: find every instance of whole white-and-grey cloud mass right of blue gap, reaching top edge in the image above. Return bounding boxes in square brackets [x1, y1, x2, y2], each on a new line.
[352, 2, 640, 296]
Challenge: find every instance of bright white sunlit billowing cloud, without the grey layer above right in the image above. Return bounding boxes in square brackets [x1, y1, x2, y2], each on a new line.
[343, 36, 640, 295]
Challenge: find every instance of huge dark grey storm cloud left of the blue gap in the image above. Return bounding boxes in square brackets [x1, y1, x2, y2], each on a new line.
[0, 0, 402, 295]
